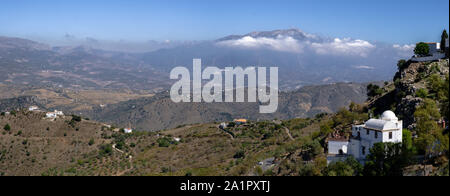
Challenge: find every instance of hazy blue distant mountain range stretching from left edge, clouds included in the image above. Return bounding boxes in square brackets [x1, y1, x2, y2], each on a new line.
[0, 29, 412, 91]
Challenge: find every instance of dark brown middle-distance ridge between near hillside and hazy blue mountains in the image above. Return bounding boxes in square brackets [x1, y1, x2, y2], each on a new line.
[91, 83, 367, 131]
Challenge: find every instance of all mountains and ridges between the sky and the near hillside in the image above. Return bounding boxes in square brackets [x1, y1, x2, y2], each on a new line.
[0, 29, 401, 131]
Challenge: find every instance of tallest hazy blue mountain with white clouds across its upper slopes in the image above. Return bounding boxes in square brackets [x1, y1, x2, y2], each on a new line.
[136, 29, 413, 89]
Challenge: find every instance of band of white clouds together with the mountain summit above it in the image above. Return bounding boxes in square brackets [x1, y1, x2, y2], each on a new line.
[217, 29, 415, 57]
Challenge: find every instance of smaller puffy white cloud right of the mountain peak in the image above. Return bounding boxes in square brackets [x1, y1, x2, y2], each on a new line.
[311, 38, 376, 57]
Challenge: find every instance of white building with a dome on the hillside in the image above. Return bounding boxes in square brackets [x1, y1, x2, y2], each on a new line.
[328, 111, 403, 162]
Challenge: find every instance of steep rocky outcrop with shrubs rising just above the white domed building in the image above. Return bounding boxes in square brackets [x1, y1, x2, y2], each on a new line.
[368, 59, 449, 129]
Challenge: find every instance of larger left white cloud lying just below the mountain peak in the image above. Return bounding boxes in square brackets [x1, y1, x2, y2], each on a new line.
[218, 36, 303, 53]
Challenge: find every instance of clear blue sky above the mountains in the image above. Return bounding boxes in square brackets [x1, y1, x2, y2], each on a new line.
[0, 0, 449, 44]
